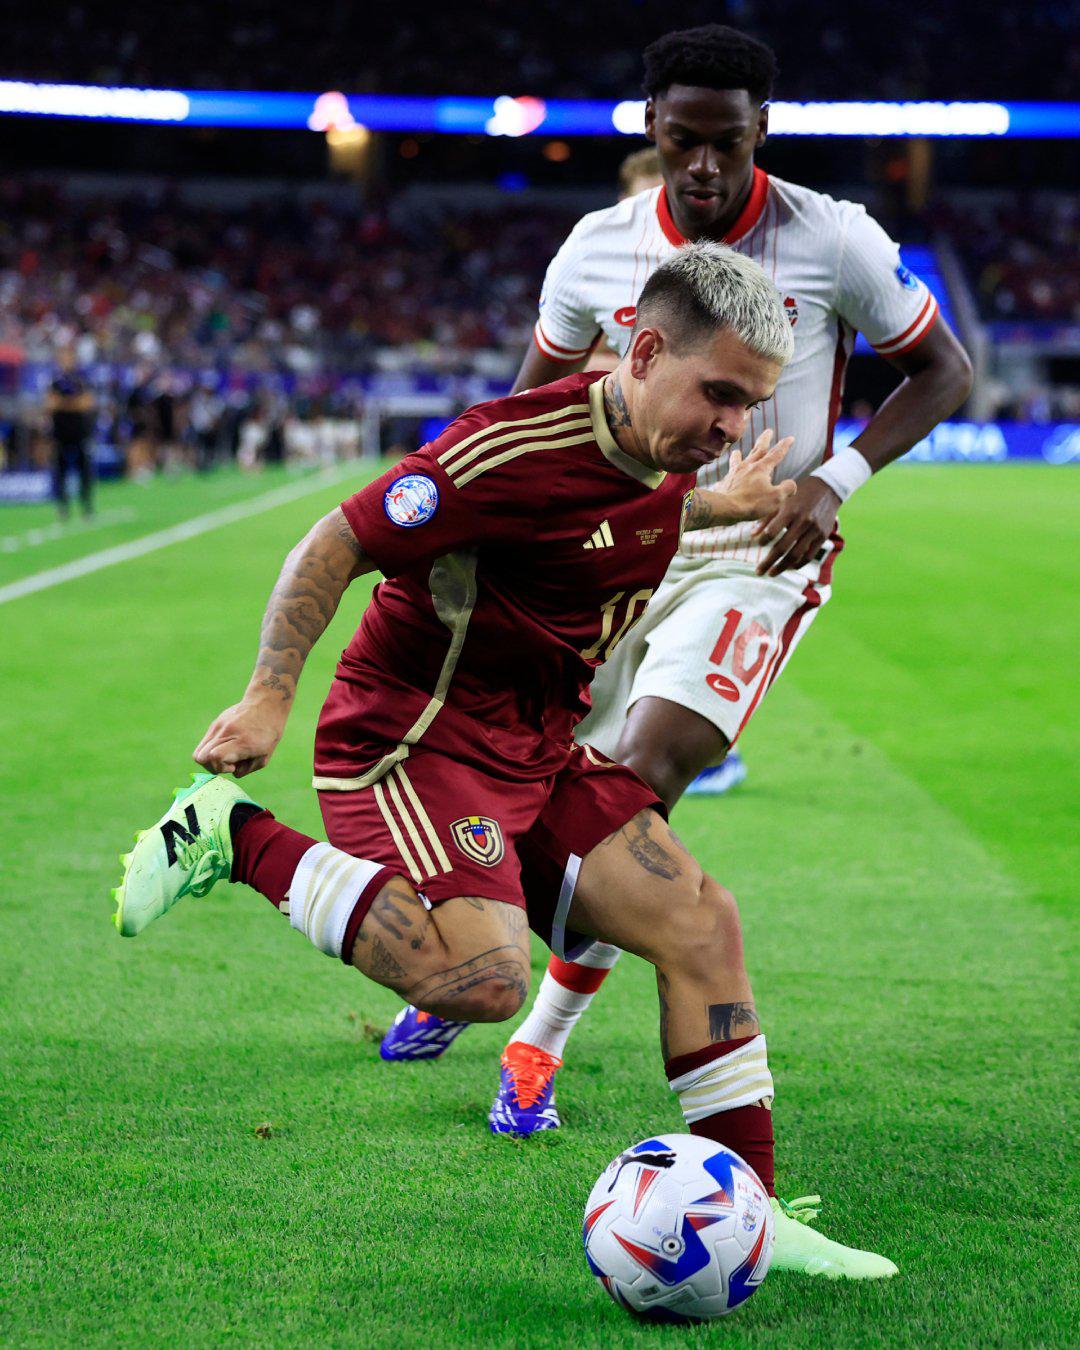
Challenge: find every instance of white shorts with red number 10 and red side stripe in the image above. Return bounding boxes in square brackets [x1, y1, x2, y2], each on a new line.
[575, 539, 844, 757]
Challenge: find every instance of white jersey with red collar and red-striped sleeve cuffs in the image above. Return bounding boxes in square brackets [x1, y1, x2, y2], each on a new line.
[535, 169, 938, 562]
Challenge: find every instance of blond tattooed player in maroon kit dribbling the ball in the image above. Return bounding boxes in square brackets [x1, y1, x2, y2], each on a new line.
[116, 243, 895, 1277]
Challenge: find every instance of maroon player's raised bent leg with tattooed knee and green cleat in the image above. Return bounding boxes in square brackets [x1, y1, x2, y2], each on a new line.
[113, 774, 529, 1022]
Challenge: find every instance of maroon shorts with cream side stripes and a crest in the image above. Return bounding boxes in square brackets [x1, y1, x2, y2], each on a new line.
[319, 745, 667, 960]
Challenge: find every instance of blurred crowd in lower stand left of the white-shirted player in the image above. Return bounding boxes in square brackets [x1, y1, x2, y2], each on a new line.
[0, 181, 574, 375]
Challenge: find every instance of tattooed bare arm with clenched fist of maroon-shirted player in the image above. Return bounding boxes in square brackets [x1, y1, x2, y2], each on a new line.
[194, 506, 375, 778]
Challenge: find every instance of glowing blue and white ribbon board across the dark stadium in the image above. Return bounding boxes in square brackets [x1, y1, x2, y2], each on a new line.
[0, 80, 1080, 138]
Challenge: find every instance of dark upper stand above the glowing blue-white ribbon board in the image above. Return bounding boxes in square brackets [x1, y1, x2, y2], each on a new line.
[4, 0, 1080, 99]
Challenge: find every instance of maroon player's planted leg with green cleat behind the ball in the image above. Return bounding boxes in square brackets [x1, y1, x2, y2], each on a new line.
[567, 810, 896, 1280]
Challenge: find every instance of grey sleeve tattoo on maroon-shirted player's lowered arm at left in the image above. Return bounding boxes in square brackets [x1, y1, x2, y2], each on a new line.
[252, 508, 371, 702]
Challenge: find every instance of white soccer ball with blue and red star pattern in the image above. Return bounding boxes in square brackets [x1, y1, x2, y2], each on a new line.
[583, 1134, 775, 1322]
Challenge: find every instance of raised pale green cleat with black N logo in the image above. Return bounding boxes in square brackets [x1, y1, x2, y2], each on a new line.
[112, 774, 258, 937]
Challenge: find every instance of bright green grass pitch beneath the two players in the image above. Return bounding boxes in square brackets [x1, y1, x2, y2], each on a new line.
[0, 466, 1080, 1347]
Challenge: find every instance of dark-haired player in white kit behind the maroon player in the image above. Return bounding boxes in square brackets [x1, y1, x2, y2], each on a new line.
[383, 24, 972, 1242]
